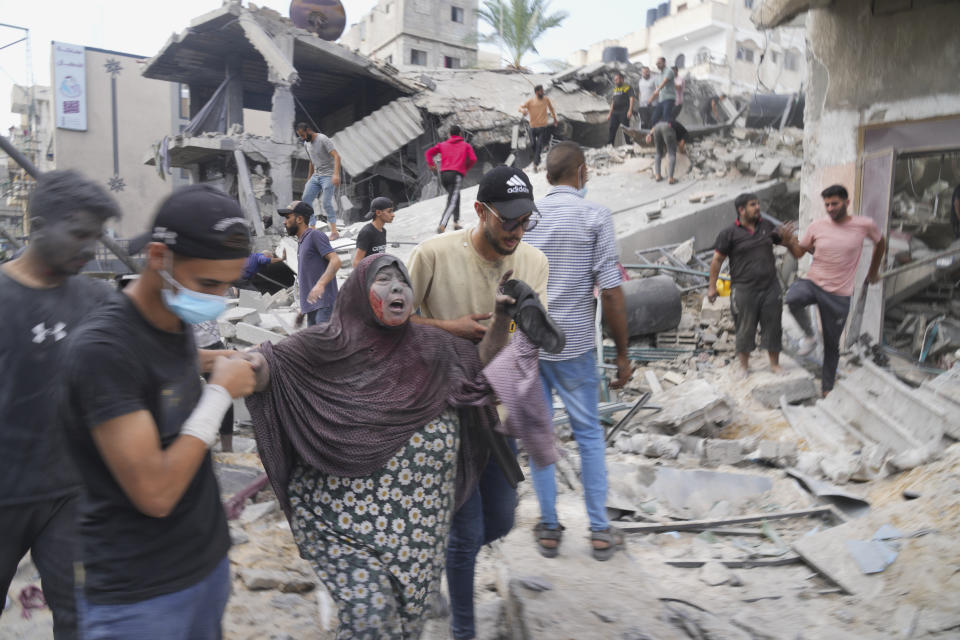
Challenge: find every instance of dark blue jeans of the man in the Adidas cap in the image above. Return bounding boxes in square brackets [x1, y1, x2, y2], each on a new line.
[447, 439, 517, 640]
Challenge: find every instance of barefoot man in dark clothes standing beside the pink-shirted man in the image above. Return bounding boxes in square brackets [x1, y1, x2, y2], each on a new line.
[707, 193, 793, 378]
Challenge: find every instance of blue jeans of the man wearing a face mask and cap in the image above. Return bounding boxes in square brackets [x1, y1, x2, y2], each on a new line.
[77, 556, 230, 640]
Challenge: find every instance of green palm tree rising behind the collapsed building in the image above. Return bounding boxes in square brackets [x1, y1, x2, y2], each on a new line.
[477, 0, 568, 70]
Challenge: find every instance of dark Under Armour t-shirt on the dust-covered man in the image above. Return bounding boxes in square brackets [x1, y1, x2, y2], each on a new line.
[0, 269, 117, 504]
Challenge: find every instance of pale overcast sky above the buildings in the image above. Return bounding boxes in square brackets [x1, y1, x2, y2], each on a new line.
[0, 0, 656, 133]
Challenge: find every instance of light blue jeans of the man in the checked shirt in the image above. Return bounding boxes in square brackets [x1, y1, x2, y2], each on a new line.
[530, 351, 610, 531]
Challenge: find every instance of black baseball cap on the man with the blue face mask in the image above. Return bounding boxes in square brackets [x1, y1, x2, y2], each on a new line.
[129, 184, 250, 260]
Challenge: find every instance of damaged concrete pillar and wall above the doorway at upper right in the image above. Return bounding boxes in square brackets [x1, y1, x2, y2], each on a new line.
[800, 0, 960, 229]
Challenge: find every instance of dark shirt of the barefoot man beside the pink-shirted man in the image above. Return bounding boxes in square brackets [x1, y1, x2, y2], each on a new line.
[713, 218, 780, 288]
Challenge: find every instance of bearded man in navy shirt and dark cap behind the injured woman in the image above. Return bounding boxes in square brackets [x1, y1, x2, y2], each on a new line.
[277, 200, 341, 327]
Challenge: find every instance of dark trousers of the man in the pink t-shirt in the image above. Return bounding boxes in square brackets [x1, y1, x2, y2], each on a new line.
[785, 279, 850, 393]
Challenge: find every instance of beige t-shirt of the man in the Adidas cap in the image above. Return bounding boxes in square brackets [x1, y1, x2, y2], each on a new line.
[407, 229, 550, 324]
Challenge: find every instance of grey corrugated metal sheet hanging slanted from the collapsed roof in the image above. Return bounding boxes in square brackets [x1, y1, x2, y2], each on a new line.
[333, 98, 423, 176]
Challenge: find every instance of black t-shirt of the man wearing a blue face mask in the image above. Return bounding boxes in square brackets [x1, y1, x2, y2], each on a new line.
[62, 295, 230, 604]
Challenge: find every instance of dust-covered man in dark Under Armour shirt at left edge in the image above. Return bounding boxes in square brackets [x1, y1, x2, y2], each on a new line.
[0, 171, 120, 640]
